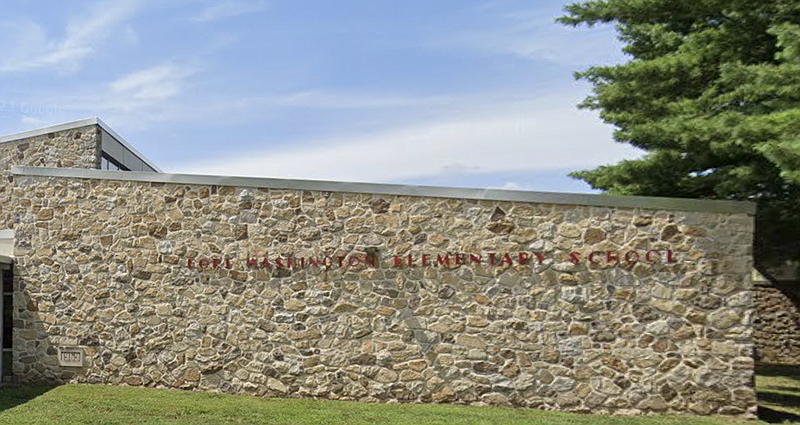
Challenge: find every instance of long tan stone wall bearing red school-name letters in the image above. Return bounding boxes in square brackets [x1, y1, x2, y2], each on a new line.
[9, 175, 755, 416]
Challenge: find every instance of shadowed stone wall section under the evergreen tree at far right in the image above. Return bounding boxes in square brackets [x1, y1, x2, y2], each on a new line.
[753, 280, 800, 365]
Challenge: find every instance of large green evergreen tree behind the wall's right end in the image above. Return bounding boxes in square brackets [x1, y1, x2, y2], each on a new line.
[559, 0, 800, 276]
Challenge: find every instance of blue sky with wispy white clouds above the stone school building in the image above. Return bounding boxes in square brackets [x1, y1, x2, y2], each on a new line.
[0, 0, 637, 192]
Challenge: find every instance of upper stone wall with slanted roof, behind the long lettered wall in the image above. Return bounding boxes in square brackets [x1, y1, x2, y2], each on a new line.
[0, 126, 101, 230]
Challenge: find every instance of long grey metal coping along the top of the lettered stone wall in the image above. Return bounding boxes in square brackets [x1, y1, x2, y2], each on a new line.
[11, 166, 756, 214]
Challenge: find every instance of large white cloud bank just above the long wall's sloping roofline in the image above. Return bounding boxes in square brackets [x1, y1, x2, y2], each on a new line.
[175, 94, 637, 182]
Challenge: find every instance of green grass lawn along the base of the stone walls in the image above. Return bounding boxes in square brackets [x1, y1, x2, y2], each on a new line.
[0, 367, 800, 425]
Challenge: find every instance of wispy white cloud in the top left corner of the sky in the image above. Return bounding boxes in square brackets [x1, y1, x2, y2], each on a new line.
[0, 0, 142, 72]
